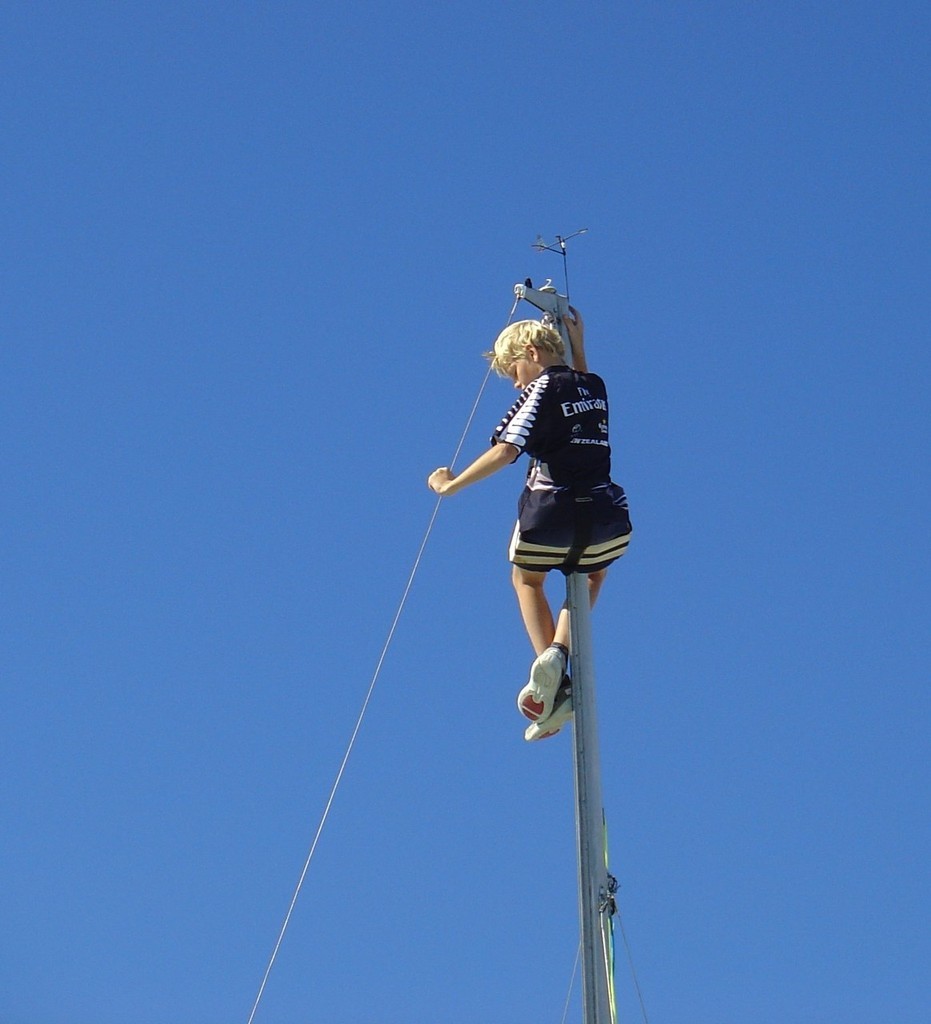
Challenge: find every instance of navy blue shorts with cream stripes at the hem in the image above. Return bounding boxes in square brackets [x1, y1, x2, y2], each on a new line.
[508, 483, 633, 572]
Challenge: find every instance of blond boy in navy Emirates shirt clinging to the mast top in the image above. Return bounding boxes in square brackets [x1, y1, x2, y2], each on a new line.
[427, 307, 631, 740]
